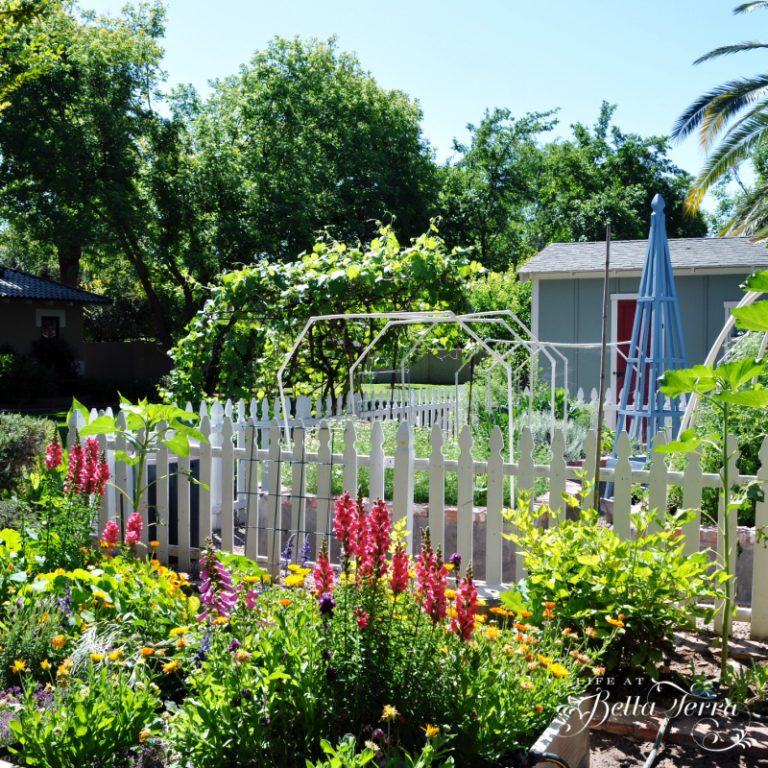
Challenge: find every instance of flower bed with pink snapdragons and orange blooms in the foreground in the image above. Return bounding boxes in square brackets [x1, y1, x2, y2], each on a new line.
[0, 428, 596, 768]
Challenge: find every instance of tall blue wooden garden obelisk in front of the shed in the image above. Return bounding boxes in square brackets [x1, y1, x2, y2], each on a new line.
[614, 195, 687, 449]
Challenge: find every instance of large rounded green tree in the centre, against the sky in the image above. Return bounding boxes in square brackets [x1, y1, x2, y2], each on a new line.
[185, 38, 435, 264]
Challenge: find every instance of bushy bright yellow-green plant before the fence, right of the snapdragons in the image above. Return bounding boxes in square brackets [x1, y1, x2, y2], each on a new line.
[502, 490, 715, 675]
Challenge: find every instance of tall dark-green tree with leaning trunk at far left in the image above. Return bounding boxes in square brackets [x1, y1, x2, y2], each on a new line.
[0, 0, 185, 346]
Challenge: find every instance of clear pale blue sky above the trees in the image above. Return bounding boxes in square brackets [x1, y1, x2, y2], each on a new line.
[87, 0, 768, 180]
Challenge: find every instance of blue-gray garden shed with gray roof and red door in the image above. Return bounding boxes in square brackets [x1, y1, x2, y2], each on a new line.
[519, 237, 768, 393]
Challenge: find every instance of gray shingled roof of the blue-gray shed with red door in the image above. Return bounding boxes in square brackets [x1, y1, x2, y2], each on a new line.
[518, 237, 768, 277]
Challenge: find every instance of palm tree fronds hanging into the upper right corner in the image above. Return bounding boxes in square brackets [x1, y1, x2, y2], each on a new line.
[672, 0, 768, 222]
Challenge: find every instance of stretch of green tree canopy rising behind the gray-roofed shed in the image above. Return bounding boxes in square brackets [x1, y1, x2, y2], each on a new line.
[440, 103, 707, 269]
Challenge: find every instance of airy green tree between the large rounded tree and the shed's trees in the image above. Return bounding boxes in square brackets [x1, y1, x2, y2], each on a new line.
[438, 109, 556, 270]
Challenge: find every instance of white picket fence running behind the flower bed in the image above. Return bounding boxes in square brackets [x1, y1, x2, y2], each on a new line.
[70, 405, 768, 637]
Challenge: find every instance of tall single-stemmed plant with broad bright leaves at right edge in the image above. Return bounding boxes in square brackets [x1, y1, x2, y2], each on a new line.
[657, 271, 768, 682]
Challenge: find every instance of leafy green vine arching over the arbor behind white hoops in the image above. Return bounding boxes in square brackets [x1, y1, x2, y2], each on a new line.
[166, 227, 482, 402]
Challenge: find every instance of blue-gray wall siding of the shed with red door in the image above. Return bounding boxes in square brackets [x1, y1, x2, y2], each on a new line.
[538, 272, 748, 393]
